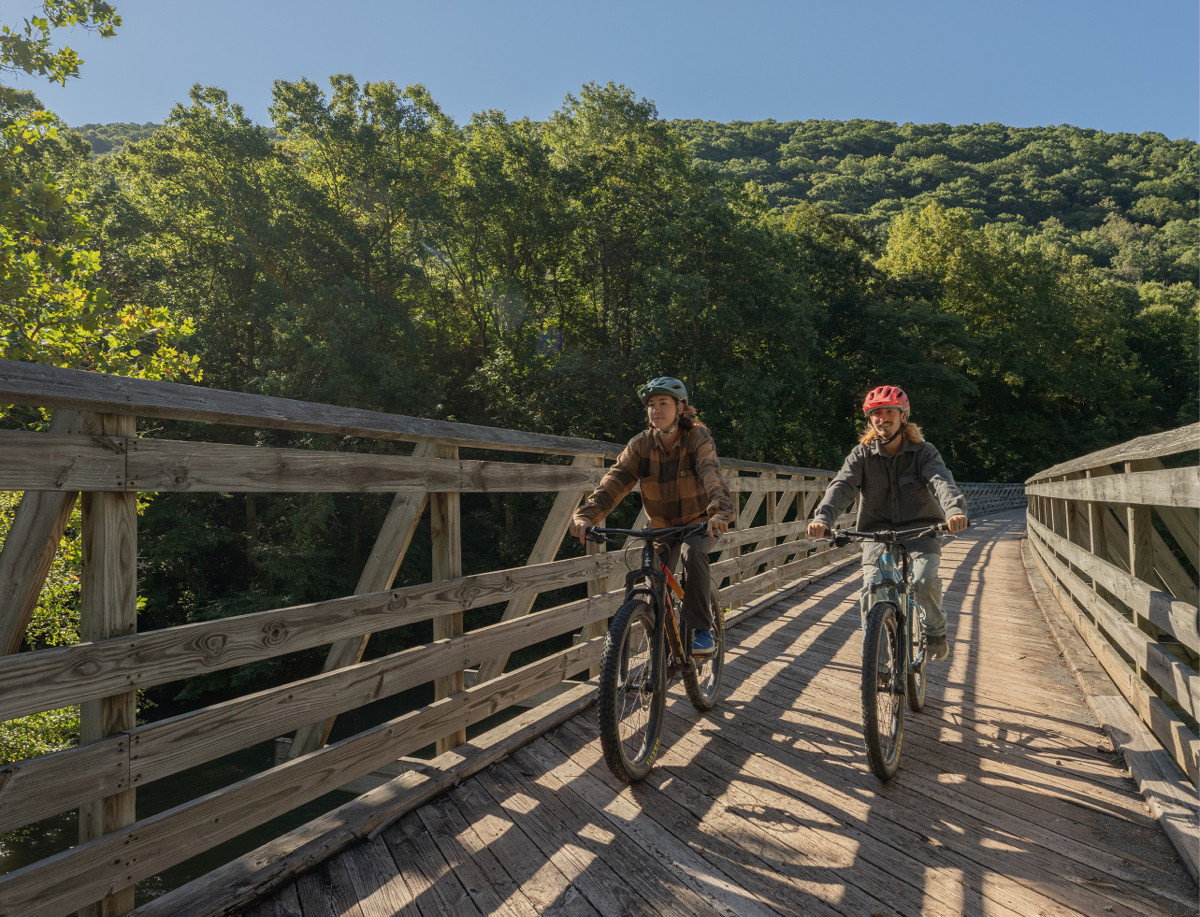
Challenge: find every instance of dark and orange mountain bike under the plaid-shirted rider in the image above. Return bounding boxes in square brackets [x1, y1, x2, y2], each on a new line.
[587, 523, 725, 784]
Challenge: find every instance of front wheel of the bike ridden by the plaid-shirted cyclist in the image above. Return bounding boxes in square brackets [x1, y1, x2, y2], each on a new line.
[599, 601, 666, 784]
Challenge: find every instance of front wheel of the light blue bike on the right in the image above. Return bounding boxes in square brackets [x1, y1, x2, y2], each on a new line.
[863, 601, 905, 780]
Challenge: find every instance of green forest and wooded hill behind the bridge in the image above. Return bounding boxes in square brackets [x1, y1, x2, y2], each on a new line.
[0, 76, 1198, 710]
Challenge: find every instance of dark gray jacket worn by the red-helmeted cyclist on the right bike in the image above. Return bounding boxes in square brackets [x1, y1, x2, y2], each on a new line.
[812, 439, 967, 564]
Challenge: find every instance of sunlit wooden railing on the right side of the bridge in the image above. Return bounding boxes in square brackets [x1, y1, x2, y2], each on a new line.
[1026, 424, 1200, 875]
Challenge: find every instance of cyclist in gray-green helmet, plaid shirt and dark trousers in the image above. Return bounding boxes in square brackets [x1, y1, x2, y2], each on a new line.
[571, 376, 737, 655]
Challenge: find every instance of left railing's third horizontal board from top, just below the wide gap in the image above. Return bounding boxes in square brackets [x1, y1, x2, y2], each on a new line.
[0, 544, 638, 719]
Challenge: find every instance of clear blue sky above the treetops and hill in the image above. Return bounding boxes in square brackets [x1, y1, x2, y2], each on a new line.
[9, 0, 1200, 139]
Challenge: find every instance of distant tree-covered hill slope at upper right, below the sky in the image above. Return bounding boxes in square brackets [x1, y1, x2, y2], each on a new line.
[673, 120, 1200, 286]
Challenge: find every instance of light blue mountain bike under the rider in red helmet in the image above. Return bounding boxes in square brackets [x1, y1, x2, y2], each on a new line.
[824, 525, 947, 780]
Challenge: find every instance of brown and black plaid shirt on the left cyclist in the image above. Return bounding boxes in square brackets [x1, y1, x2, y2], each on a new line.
[572, 426, 737, 528]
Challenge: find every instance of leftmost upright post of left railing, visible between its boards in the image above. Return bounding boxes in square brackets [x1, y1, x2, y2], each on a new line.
[79, 414, 138, 917]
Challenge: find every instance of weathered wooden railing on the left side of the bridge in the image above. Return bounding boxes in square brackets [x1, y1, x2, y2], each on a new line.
[0, 360, 853, 917]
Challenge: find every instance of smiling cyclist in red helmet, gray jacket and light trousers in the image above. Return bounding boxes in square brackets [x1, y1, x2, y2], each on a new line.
[808, 385, 967, 661]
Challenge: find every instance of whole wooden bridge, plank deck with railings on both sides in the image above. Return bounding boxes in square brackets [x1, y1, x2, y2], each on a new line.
[0, 361, 1200, 917]
